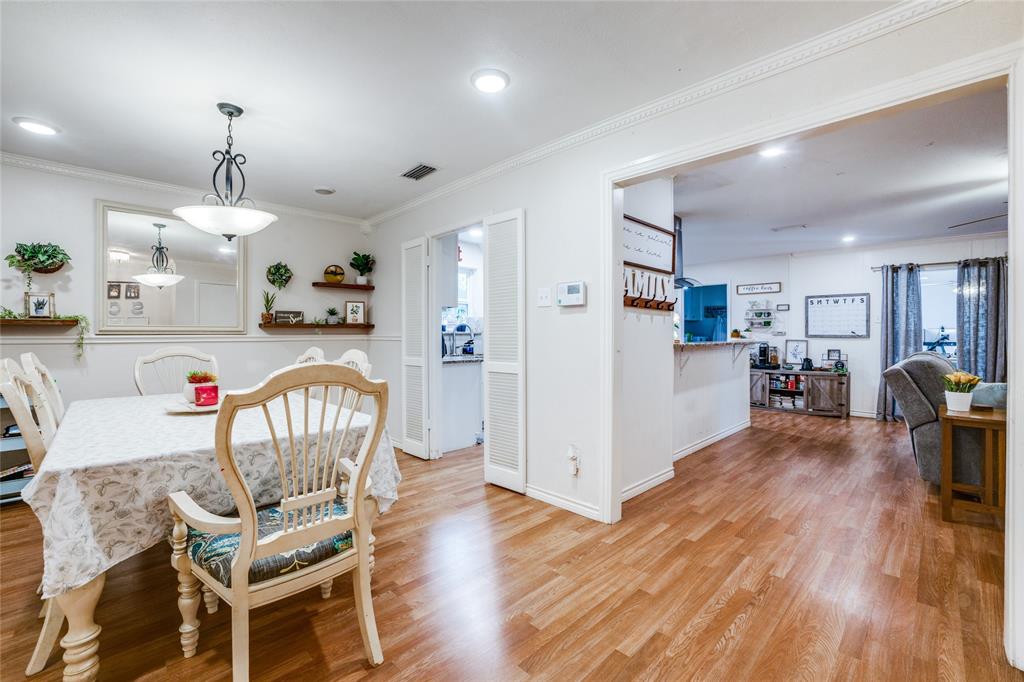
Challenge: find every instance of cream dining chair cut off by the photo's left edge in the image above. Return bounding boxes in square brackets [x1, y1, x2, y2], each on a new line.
[0, 357, 65, 676]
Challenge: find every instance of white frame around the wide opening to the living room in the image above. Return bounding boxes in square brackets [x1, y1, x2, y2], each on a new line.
[598, 41, 1024, 668]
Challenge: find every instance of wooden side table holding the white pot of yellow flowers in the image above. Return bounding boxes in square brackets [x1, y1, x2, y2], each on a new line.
[939, 404, 1007, 521]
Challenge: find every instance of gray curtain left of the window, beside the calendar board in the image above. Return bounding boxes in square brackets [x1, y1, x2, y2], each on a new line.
[874, 263, 925, 420]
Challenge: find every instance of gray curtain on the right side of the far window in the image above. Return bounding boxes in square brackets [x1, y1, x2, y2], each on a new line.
[956, 257, 1008, 383]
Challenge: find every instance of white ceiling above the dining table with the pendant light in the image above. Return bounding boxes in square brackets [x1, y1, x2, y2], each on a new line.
[0, 2, 887, 218]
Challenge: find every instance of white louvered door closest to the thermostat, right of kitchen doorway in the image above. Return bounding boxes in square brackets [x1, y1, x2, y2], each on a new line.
[483, 210, 526, 493]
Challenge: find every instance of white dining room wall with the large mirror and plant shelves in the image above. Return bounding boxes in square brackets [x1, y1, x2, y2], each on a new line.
[0, 164, 372, 400]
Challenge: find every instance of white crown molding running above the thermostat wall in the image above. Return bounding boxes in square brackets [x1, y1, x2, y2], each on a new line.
[368, 0, 971, 225]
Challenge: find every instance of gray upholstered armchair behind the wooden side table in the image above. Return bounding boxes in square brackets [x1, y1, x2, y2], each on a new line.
[882, 351, 1007, 485]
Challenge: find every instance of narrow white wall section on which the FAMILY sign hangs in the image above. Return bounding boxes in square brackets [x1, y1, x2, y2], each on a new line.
[620, 178, 675, 500]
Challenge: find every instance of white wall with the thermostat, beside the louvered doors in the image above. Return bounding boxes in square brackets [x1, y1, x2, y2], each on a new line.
[371, 3, 1024, 517]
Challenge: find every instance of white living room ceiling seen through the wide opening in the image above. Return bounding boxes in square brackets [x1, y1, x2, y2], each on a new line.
[675, 84, 1009, 264]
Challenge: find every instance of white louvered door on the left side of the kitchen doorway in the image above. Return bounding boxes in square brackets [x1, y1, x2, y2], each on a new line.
[401, 238, 430, 459]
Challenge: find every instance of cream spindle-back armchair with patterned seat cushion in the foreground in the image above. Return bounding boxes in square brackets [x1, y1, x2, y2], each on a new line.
[168, 364, 388, 680]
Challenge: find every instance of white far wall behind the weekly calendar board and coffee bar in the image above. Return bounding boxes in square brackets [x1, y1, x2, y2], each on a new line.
[686, 232, 1007, 417]
